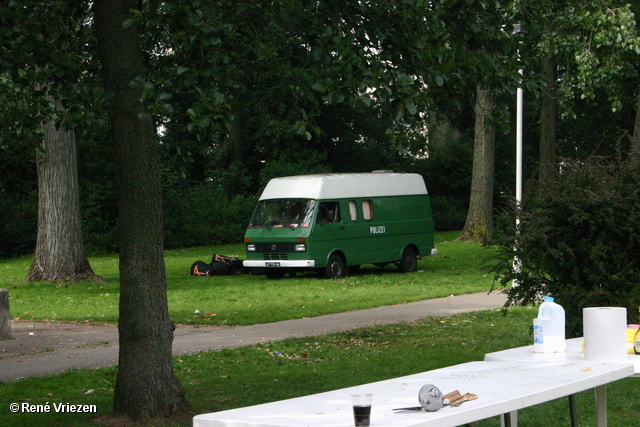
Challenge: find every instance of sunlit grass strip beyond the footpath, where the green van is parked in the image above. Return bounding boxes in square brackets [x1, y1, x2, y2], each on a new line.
[0, 232, 493, 325]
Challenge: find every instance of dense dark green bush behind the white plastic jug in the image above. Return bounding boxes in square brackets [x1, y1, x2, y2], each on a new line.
[492, 154, 640, 336]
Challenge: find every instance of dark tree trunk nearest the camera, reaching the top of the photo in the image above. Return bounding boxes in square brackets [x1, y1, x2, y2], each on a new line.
[94, 0, 188, 419]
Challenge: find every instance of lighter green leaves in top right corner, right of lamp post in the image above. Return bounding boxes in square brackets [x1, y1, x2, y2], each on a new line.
[514, 0, 640, 164]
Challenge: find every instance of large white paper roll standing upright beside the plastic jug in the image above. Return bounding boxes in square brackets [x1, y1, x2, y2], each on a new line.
[582, 307, 627, 361]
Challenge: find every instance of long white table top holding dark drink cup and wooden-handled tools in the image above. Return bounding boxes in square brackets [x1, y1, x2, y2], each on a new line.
[193, 360, 634, 427]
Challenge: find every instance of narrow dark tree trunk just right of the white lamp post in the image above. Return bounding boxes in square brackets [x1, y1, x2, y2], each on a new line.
[539, 24, 558, 185]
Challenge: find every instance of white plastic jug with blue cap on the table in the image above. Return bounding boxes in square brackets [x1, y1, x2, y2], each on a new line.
[533, 297, 565, 353]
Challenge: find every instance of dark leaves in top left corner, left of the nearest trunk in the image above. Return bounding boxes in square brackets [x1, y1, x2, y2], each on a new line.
[0, 0, 101, 141]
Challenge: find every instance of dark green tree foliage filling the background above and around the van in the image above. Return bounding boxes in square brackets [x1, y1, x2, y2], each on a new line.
[0, 0, 638, 256]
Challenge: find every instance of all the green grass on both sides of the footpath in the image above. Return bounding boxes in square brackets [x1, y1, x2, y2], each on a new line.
[0, 233, 640, 427]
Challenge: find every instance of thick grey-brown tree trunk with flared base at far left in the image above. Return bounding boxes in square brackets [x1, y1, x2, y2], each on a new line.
[25, 98, 98, 282]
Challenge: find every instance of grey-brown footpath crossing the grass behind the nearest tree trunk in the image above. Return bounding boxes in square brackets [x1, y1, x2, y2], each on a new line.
[0, 292, 506, 382]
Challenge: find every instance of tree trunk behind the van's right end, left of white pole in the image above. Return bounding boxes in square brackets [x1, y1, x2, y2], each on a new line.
[458, 87, 496, 243]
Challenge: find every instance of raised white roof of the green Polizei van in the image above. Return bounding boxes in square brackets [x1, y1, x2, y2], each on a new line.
[260, 172, 427, 200]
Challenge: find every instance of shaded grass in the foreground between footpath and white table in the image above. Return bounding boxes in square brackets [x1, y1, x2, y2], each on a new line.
[0, 308, 640, 427]
